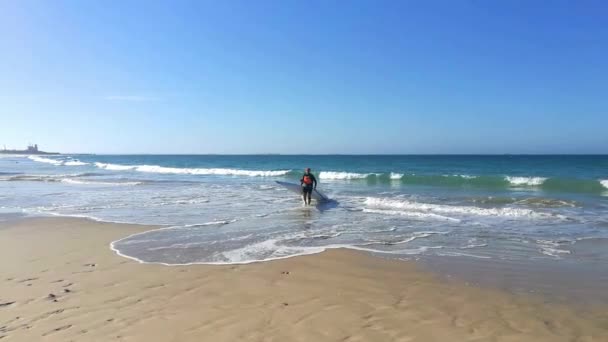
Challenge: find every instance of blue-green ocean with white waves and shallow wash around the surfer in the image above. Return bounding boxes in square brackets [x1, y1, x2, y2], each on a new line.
[0, 155, 608, 298]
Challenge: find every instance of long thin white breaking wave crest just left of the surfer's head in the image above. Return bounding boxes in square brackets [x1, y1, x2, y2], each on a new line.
[95, 163, 290, 177]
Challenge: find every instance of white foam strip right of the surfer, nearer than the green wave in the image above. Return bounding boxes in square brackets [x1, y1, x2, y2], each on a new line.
[365, 197, 542, 218]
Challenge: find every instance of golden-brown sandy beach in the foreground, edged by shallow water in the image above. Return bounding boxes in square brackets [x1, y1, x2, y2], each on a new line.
[0, 218, 608, 342]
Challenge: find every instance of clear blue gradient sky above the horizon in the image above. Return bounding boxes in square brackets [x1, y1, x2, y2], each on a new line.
[0, 0, 608, 153]
